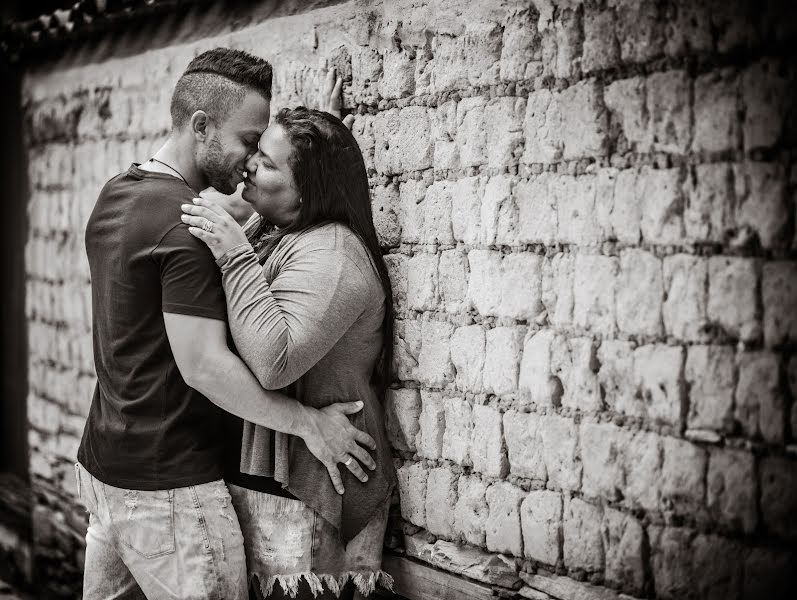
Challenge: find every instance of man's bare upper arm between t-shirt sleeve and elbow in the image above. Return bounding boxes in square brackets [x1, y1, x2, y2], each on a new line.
[163, 312, 227, 381]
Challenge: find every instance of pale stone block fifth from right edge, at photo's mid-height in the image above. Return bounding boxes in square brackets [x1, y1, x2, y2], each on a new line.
[573, 254, 618, 336]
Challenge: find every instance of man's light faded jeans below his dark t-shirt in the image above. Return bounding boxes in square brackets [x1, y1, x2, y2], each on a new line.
[75, 463, 248, 600]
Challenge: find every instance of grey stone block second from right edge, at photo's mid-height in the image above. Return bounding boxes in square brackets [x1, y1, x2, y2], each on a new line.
[707, 256, 761, 341]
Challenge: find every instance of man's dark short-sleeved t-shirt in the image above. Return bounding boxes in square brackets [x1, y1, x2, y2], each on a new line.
[78, 165, 227, 490]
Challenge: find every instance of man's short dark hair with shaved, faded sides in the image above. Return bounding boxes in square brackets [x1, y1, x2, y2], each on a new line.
[170, 48, 271, 129]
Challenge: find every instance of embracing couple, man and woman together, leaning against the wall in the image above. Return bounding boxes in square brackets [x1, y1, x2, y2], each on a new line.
[75, 48, 395, 600]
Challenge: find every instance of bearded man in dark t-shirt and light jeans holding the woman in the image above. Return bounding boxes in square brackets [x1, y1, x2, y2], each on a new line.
[76, 48, 375, 600]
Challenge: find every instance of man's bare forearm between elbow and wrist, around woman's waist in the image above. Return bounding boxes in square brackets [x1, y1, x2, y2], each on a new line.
[187, 344, 317, 438]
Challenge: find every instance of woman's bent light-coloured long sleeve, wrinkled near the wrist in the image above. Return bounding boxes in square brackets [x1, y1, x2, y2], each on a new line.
[213, 239, 371, 389]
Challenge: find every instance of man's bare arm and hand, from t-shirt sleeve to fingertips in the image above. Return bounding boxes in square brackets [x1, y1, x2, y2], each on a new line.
[163, 313, 376, 494]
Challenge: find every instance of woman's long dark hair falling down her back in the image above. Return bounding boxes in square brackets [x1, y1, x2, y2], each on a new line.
[247, 106, 394, 394]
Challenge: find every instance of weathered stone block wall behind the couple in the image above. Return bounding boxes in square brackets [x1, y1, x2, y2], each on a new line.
[25, 0, 797, 598]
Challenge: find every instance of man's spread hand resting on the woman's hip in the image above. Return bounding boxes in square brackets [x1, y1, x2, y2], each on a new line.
[302, 402, 376, 494]
